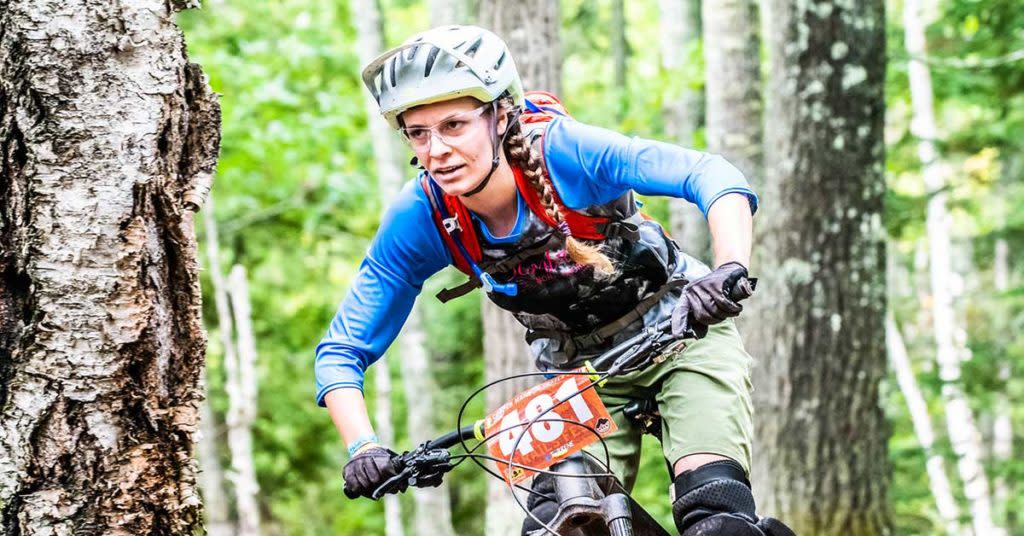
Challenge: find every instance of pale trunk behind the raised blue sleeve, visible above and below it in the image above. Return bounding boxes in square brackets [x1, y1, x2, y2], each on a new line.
[658, 0, 711, 258]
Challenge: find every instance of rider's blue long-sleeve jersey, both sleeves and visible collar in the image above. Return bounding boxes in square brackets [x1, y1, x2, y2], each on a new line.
[315, 118, 757, 406]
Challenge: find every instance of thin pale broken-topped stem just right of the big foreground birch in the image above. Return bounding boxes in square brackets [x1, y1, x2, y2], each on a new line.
[224, 264, 260, 536]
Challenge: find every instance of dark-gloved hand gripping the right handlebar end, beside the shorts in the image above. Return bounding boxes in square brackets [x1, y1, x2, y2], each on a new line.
[672, 262, 754, 338]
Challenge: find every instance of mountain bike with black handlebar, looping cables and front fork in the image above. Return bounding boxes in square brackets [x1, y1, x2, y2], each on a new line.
[345, 279, 757, 536]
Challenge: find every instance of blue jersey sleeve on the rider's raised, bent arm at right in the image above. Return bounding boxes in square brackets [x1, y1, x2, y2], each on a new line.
[544, 118, 758, 217]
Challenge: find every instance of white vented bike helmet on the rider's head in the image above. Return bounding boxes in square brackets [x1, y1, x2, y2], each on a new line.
[362, 26, 523, 128]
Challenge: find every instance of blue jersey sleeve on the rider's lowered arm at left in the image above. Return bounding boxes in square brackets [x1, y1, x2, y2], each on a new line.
[314, 180, 451, 406]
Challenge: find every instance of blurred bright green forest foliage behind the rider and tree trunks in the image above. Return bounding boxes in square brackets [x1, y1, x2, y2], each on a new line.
[178, 0, 1024, 535]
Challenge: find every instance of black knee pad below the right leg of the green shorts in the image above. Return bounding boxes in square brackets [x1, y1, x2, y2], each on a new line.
[672, 460, 764, 536]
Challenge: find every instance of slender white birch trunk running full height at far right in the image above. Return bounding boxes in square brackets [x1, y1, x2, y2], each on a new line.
[903, 0, 1002, 536]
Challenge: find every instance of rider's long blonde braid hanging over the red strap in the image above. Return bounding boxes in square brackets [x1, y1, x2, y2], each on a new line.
[505, 109, 615, 277]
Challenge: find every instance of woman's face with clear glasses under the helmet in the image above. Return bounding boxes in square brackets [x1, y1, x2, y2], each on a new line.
[401, 96, 506, 196]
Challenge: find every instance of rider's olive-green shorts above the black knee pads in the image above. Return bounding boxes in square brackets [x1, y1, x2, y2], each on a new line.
[587, 321, 754, 490]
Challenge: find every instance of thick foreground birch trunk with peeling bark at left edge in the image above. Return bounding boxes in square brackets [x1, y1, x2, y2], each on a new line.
[0, 0, 219, 536]
